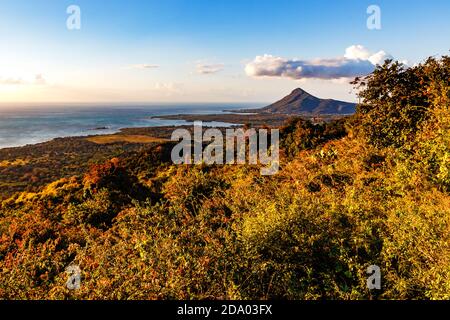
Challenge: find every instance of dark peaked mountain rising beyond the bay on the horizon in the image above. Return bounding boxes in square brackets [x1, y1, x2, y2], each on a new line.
[253, 88, 356, 114]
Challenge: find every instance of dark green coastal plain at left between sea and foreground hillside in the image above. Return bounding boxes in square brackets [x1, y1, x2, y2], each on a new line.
[0, 135, 162, 200]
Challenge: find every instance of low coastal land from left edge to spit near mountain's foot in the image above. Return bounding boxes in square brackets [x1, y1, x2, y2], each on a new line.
[0, 110, 287, 200]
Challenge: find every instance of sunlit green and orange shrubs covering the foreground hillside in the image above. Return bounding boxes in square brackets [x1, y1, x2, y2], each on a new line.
[0, 57, 450, 299]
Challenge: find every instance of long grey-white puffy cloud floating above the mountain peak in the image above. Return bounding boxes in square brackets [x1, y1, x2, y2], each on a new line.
[245, 45, 392, 80]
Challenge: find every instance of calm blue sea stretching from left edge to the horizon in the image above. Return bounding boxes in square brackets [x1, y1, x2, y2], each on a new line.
[0, 104, 262, 148]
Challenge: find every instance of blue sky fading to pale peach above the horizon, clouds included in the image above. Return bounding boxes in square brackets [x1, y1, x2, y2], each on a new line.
[0, 0, 450, 104]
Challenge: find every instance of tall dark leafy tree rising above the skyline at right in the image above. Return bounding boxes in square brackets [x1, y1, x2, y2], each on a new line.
[352, 56, 450, 147]
